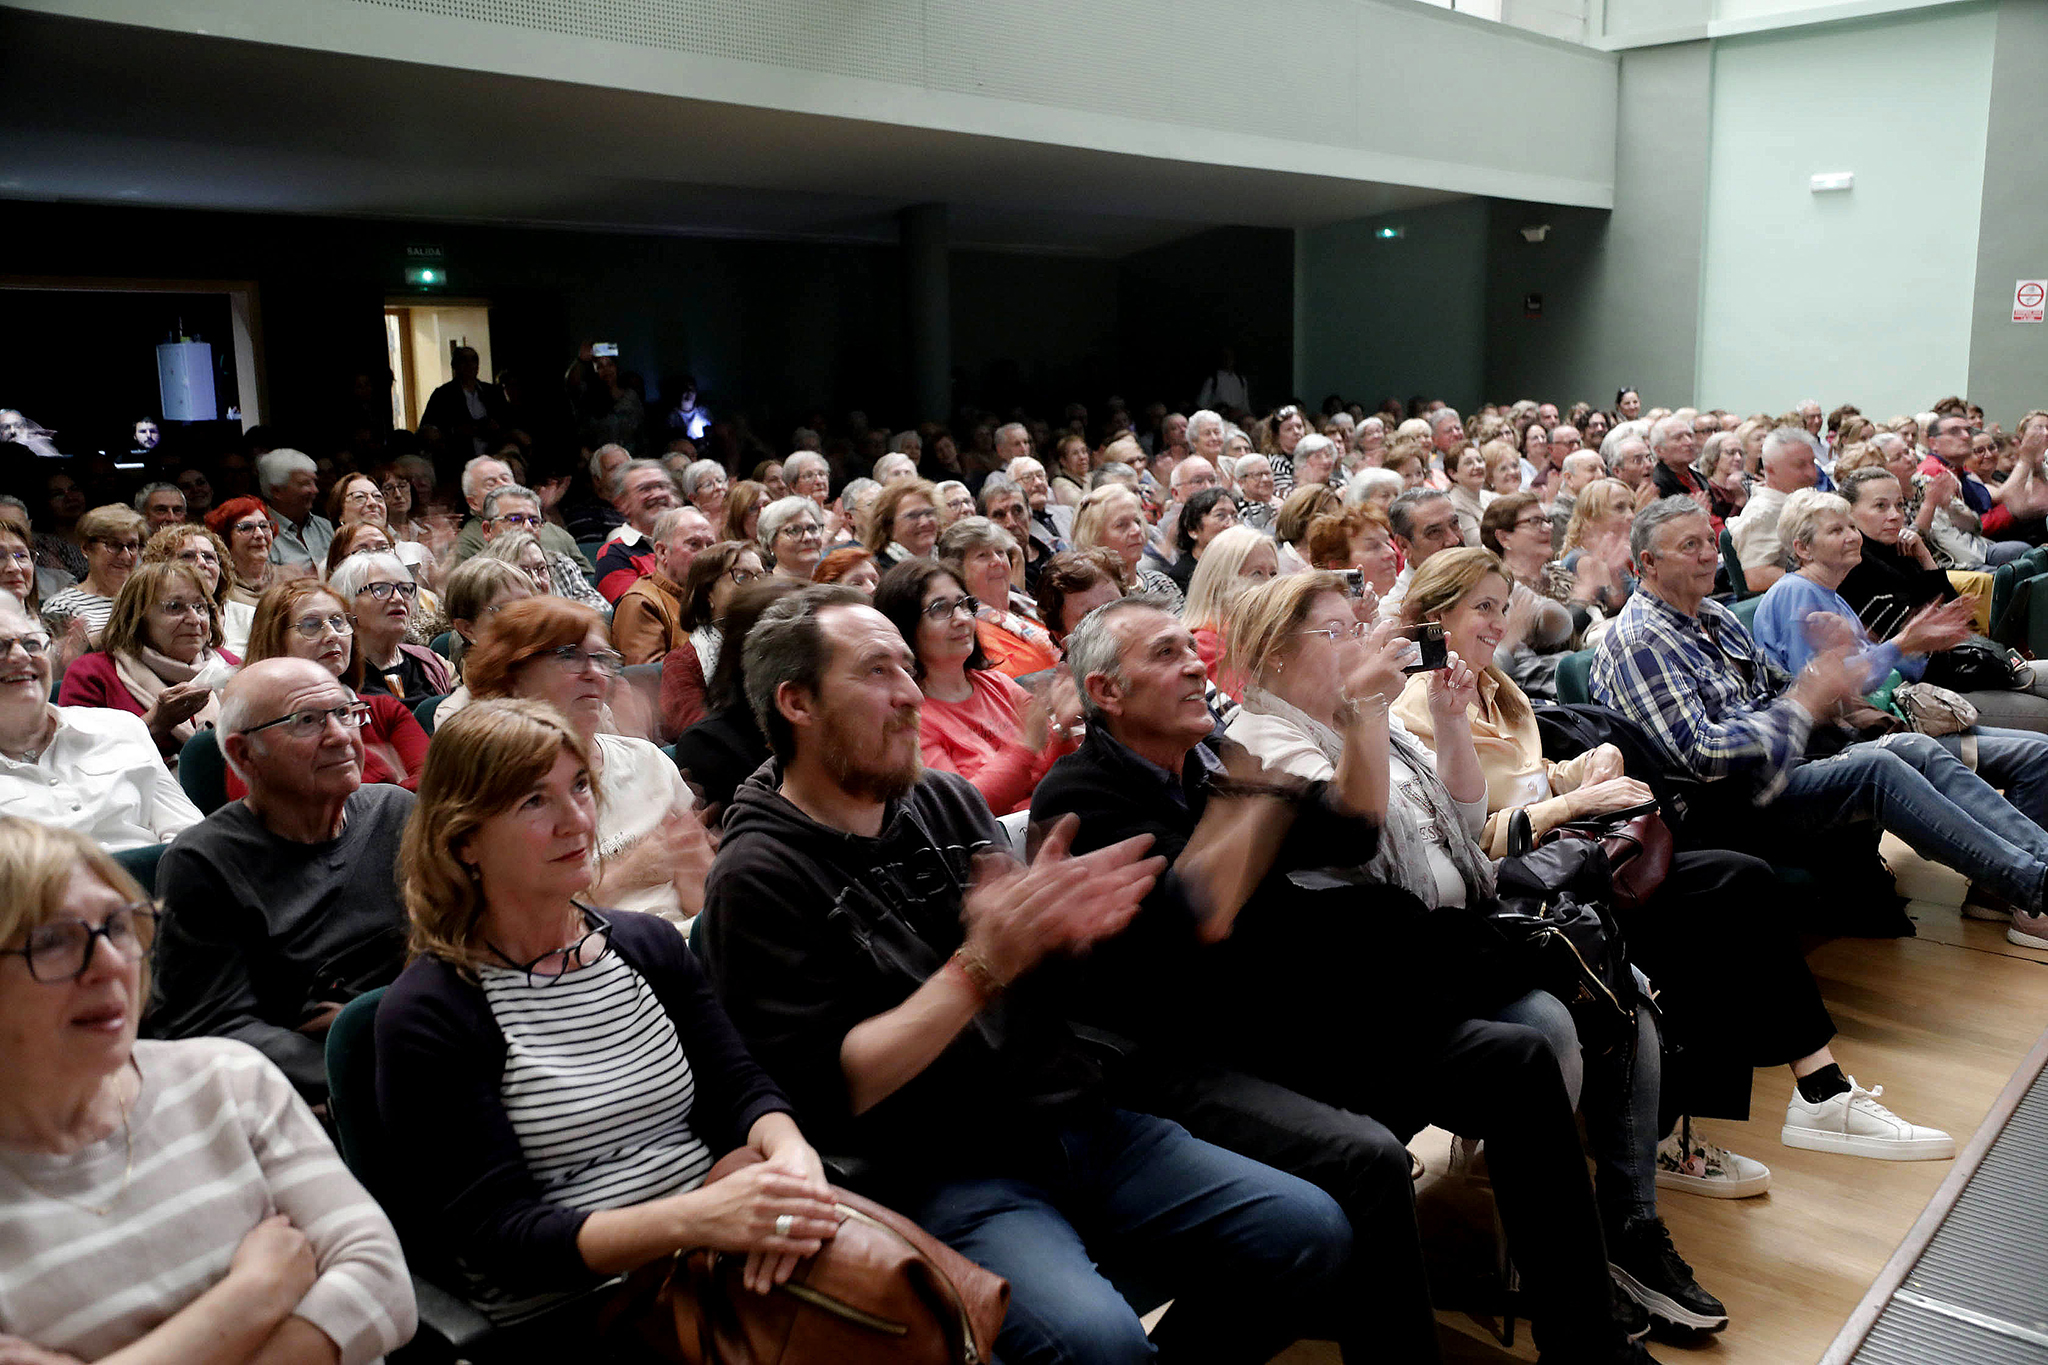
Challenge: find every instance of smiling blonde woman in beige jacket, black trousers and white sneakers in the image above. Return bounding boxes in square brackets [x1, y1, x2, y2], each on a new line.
[1395, 551, 1954, 1199]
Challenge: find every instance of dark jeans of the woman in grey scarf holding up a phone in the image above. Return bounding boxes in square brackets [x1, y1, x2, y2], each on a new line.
[1493, 972, 1663, 1238]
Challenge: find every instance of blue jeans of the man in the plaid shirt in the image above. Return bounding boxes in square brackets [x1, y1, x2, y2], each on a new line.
[1759, 731, 2048, 911]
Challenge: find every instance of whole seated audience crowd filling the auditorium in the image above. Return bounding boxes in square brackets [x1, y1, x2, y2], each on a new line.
[0, 366, 2048, 1365]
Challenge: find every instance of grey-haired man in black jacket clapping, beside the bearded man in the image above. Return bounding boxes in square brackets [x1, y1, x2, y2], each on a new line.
[1032, 598, 1645, 1361]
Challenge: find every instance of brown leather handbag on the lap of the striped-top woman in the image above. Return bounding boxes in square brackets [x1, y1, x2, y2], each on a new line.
[604, 1148, 1010, 1365]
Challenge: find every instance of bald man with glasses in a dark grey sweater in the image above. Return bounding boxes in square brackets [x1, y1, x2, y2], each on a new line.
[150, 659, 412, 1105]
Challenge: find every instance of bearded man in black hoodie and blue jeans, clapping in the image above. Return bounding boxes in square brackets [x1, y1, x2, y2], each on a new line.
[705, 585, 1352, 1365]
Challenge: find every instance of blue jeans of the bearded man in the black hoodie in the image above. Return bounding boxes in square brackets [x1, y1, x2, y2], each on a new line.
[903, 1109, 1352, 1365]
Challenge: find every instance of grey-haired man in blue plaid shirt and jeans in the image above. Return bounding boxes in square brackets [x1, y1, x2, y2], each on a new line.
[1591, 497, 2048, 957]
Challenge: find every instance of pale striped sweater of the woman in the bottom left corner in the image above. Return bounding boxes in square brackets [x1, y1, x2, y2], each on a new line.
[0, 1038, 414, 1365]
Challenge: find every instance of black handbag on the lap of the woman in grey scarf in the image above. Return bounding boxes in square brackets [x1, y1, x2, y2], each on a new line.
[1487, 810, 1638, 1054]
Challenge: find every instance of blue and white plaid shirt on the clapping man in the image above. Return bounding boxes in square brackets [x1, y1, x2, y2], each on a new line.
[1591, 587, 1812, 806]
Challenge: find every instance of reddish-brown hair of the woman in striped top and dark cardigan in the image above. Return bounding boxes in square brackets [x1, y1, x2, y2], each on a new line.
[399, 700, 590, 970]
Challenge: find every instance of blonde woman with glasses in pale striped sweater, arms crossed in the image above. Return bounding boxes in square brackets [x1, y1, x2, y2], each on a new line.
[0, 814, 416, 1365]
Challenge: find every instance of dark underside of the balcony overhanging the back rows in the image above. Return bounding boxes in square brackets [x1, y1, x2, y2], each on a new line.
[0, 8, 1460, 256]
